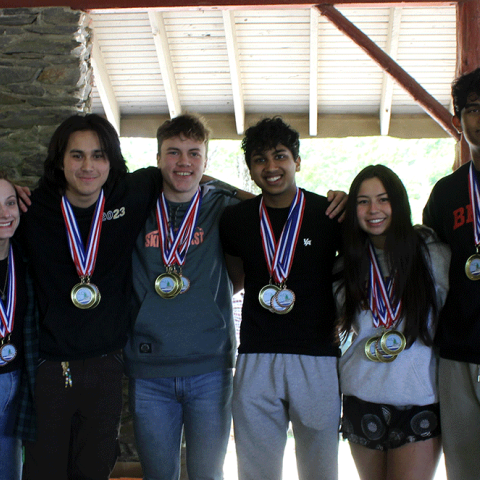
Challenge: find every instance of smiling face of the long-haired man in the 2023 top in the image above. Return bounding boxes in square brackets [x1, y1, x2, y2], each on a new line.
[63, 130, 110, 208]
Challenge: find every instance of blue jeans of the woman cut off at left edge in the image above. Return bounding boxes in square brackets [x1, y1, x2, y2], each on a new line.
[0, 370, 22, 480]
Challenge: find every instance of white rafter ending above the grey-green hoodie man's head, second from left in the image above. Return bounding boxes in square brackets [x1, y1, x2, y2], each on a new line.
[148, 10, 182, 118]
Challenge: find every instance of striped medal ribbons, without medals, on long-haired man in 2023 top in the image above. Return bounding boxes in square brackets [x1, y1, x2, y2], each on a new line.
[62, 190, 105, 278]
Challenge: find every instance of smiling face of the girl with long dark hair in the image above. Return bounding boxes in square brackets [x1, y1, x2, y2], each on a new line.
[357, 177, 392, 249]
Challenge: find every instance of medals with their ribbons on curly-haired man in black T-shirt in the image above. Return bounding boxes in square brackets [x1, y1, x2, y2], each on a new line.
[258, 188, 305, 315]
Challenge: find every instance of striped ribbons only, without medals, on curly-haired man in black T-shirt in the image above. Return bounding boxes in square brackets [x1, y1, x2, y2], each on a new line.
[260, 187, 305, 285]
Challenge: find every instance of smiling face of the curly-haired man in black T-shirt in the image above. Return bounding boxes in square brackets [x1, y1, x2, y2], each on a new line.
[250, 144, 301, 208]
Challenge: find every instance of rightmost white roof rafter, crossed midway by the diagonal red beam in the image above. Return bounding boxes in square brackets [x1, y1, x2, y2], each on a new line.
[380, 7, 402, 135]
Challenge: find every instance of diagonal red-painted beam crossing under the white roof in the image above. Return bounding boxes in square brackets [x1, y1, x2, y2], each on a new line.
[317, 5, 460, 140]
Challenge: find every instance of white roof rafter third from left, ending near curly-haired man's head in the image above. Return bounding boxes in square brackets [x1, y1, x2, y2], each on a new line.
[222, 10, 245, 135]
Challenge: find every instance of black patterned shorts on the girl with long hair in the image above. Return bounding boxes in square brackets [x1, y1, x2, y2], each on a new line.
[341, 395, 441, 450]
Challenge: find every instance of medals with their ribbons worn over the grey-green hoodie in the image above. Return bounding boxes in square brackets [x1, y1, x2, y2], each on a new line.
[155, 188, 202, 298]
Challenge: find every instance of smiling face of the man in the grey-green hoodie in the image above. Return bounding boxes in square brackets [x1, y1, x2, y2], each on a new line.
[157, 135, 207, 203]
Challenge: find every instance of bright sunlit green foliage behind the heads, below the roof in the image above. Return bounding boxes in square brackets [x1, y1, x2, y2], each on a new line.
[121, 137, 455, 223]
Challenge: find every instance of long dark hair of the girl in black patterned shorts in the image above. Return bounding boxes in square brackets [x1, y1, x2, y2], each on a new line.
[338, 165, 437, 346]
